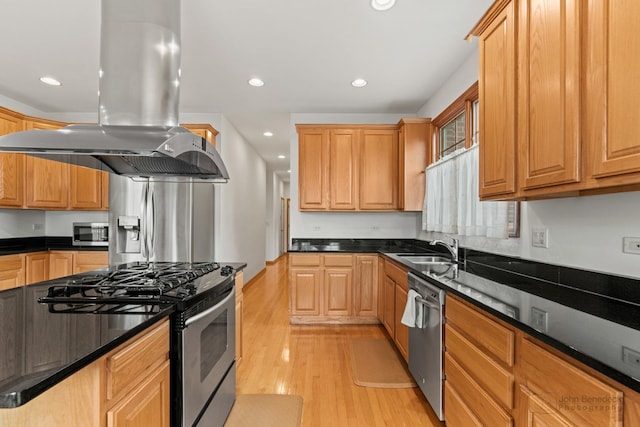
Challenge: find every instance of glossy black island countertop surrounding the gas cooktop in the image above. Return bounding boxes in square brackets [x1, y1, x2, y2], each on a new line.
[0, 262, 246, 408]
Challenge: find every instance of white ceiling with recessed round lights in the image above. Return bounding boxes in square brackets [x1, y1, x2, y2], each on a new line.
[0, 0, 492, 182]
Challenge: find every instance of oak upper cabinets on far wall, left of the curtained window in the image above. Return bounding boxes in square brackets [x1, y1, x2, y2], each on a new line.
[296, 119, 431, 211]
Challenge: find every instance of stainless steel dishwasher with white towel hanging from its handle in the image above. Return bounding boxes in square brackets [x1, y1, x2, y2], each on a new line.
[409, 273, 445, 421]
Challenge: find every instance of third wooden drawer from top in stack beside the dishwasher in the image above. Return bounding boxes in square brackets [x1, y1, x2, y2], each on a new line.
[445, 354, 513, 427]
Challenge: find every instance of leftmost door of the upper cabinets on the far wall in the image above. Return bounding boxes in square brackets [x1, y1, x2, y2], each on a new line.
[298, 129, 329, 210]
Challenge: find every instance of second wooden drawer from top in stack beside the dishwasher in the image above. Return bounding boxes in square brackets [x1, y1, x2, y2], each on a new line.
[445, 324, 514, 408]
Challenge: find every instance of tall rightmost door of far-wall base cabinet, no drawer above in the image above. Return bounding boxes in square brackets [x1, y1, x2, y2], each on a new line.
[354, 255, 378, 317]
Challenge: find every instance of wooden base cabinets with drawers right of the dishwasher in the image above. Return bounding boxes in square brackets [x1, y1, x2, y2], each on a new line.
[444, 294, 640, 427]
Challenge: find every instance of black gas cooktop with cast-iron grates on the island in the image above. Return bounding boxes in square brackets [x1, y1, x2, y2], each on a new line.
[38, 262, 233, 313]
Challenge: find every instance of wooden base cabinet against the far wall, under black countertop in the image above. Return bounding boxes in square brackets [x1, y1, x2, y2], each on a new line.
[289, 253, 378, 324]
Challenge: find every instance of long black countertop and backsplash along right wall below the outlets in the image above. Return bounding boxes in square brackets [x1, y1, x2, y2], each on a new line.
[383, 250, 640, 392]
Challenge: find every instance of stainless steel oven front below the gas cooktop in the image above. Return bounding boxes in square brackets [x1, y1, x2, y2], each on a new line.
[173, 288, 236, 427]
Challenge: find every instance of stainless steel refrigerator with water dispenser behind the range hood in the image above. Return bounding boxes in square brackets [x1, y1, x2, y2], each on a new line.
[109, 174, 215, 264]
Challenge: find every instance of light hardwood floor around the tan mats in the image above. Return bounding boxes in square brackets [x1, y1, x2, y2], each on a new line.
[237, 256, 441, 427]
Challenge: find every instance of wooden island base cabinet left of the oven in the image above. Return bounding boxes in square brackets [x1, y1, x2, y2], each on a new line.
[0, 319, 171, 427]
